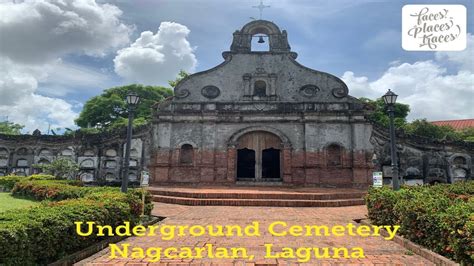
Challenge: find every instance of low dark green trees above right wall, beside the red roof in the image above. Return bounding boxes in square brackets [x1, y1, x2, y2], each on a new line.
[404, 119, 462, 140]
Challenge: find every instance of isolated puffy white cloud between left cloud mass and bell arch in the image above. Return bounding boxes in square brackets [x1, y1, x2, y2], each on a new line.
[114, 22, 197, 85]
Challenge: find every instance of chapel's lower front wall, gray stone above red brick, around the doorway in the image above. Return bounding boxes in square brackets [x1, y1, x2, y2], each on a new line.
[150, 97, 373, 187]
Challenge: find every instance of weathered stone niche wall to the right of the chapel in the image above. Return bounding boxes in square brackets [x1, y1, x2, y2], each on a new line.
[371, 127, 474, 184]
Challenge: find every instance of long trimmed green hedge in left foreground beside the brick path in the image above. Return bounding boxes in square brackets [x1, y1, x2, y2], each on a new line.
[0, 199, 137, 265]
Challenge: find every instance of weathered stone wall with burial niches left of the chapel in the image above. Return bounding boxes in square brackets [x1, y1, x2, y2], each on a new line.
[0, 127, 151, 183]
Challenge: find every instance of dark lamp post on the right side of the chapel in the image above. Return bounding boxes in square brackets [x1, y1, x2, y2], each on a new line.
[382, 90, 400, 190]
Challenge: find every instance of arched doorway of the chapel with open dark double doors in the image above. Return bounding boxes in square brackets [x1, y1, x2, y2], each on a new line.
[237, 131, 282, 181]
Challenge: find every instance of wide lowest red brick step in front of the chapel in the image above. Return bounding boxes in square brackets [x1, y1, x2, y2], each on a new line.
[153, 195, 365, 207]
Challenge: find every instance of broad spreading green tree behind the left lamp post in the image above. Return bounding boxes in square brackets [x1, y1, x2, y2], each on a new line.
[75, 84, 172, 129]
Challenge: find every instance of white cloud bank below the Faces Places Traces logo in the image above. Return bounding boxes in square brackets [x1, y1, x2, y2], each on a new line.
[342, 35, 474, 120]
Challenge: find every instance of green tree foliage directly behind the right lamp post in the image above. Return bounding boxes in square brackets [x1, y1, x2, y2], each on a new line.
[359, 98, 410, 128]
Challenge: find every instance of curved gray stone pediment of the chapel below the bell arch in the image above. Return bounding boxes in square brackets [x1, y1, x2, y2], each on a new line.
[173, 52, 354, 103]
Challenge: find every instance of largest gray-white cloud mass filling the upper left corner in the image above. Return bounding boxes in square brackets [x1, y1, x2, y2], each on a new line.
[0, 0, 133, 132]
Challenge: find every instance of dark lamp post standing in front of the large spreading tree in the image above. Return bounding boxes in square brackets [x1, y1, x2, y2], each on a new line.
[121, 92, 140, 193]
